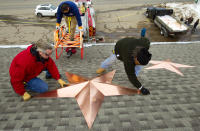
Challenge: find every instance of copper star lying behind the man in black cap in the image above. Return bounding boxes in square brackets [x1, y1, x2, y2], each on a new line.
[145, 59, 194, 76]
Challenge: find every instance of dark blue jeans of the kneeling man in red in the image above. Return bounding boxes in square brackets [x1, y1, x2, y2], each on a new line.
[26, 77, 48, 93]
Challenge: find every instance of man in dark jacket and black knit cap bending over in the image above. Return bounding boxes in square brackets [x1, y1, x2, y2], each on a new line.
[96, 37, 151, 95]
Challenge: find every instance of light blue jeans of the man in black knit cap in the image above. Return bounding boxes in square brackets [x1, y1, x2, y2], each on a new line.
[101, 53, 143, 76]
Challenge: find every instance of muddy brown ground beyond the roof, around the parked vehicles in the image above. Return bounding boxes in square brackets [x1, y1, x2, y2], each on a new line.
[0, 0, 199, 44]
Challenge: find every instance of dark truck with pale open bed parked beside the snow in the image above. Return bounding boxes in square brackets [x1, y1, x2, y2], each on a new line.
[146, 7, 188, 37]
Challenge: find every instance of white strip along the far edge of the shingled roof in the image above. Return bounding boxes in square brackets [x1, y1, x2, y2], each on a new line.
[0, 41, 200, 48]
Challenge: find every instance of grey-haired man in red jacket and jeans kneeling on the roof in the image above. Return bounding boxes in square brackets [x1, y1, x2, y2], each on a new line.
[9, 40, 66, 101]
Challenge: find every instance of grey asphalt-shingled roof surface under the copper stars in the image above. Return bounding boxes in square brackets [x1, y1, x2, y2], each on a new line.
[0, 43, 200, 131]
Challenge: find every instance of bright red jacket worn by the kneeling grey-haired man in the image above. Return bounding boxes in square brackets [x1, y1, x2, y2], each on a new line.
[9, 45, 60, 95]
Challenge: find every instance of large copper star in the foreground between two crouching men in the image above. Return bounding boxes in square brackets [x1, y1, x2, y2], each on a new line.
[37, 70, 140, 128]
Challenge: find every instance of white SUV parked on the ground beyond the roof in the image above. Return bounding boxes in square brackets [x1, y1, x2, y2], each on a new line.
[35, 4, 58, 17]
